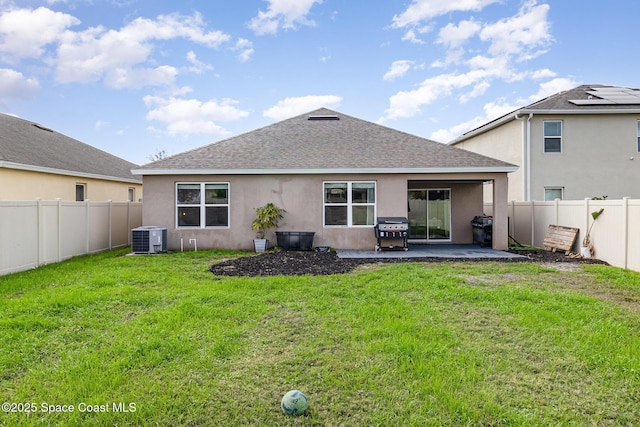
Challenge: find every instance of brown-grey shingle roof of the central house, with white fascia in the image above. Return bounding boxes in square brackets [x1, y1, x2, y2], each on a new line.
[133, 108, 517, 175]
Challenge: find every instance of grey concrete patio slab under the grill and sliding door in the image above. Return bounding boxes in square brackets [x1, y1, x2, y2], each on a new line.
[336, 245, 524, 259]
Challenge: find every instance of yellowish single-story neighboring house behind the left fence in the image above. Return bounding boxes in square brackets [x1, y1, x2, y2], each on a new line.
[0, 114, 142, 202]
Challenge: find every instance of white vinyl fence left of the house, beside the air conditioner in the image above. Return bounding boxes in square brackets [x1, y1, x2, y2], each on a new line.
[0, 200, 142, 275]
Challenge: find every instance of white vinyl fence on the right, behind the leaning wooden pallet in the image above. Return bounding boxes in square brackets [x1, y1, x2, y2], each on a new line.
[485, 198, 640, 271]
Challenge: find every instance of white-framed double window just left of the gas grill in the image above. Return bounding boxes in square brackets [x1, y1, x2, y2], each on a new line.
[324, 182, 376, 227]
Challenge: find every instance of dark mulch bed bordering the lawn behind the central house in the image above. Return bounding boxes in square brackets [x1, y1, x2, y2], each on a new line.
[209, 250, 606, 276]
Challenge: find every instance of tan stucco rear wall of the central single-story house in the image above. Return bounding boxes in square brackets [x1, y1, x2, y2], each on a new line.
[143, 173, 507, 250]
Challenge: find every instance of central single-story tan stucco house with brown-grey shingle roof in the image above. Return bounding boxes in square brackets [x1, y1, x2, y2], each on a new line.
[133, 109, 517, 249]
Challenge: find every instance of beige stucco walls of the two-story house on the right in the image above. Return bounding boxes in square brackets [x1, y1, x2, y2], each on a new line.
[454, 114, 640, 201]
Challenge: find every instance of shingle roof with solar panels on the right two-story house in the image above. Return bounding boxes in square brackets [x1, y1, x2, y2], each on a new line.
[450, 84, 640, 145]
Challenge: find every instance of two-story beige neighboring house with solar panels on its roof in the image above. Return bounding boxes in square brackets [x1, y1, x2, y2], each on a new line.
[450, 85, 640, 201]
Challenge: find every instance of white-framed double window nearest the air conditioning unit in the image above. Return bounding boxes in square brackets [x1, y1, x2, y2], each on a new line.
[176, 182, 229, 228]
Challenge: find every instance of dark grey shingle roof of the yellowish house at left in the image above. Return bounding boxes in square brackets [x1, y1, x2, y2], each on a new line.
[0, 114, 141, 184]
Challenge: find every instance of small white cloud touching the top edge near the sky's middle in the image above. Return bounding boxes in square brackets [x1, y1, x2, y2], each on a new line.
[248, 0, 322, 35]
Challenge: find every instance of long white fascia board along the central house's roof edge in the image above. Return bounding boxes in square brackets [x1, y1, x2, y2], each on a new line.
[131, 166, 518, 175]
